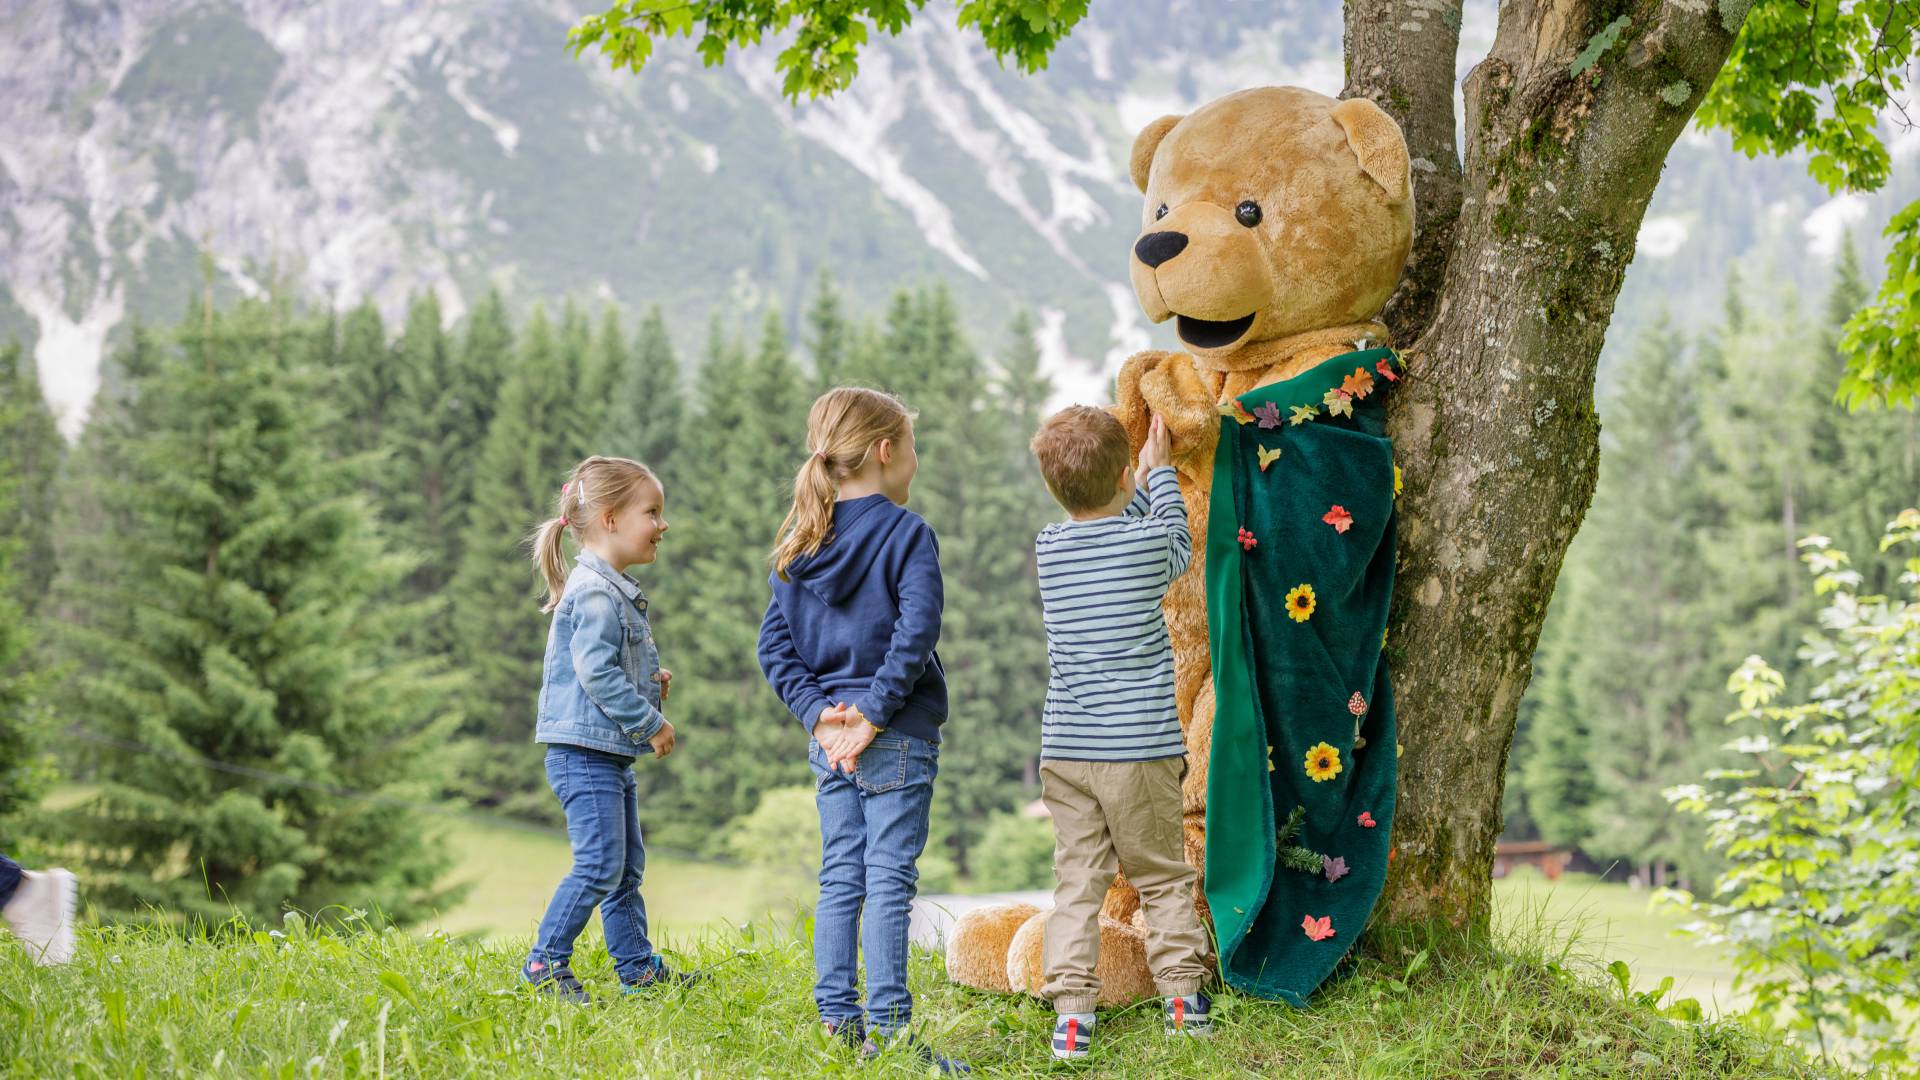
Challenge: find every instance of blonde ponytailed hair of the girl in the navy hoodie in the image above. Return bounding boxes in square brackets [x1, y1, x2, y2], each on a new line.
[772, 386, 914, 580]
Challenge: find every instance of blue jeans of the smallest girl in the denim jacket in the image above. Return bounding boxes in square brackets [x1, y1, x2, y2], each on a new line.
[526, 746, 659, 982]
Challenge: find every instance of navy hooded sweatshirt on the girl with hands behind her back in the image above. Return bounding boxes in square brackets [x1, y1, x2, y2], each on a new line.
[760, 496, 947, 742]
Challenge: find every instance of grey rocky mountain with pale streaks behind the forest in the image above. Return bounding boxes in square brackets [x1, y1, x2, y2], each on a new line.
[0, 0, 1920, 430]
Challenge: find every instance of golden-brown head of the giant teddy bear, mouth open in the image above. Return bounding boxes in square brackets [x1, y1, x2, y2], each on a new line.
[1131, 86, 1413, 369]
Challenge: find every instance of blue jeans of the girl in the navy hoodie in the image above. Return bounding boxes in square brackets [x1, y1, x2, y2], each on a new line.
[806, 732, 939, 1036]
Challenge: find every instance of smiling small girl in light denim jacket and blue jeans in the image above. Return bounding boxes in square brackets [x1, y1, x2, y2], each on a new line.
[520, 457, 699, 1003]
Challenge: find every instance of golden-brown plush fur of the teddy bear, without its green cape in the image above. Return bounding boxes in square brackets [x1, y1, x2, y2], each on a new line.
[947, 86, 1413, 1005]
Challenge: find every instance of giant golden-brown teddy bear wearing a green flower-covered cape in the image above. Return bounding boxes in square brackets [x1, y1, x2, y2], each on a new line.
[947, 86, 1413, 1005]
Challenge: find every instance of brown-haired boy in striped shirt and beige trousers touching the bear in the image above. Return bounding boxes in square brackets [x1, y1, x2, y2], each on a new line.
[1033, 405, 1212, 1059]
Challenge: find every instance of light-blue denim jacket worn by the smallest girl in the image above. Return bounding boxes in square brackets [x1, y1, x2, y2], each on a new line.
[534, 552, 666, 757]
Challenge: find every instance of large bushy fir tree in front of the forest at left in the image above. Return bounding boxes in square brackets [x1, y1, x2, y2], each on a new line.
[62, 295, 451, 922]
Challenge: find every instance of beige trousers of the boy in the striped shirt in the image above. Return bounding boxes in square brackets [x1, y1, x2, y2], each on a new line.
[1041, 757, 1208, 1013]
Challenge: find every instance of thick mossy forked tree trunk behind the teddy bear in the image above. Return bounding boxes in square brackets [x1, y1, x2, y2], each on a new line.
[1346, 0, 1745, 932]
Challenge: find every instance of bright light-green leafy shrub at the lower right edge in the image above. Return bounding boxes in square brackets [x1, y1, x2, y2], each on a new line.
[1668, 509, 1920, 1072]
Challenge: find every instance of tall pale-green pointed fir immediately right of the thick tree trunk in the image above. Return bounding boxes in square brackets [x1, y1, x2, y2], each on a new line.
[1526, 317, 1718, 878]
